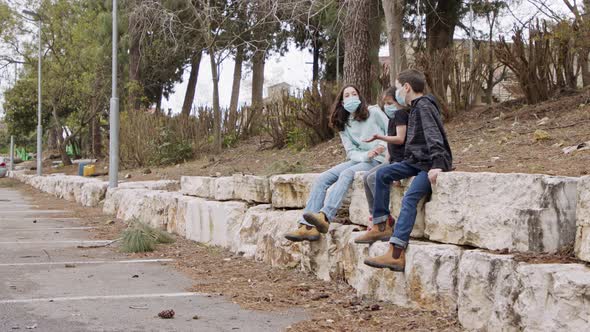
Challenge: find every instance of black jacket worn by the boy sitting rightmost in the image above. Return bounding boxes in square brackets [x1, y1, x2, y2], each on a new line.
[404, 96, 453, 172]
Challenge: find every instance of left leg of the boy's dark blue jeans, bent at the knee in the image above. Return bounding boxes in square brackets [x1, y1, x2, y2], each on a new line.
[373, 161, 420, 225]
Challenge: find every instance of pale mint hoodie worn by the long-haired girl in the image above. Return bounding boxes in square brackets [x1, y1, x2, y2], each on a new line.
[340, 106, 389, 163]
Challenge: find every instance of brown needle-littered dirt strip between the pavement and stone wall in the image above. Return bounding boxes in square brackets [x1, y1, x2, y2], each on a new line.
[0, 179, 462, 331]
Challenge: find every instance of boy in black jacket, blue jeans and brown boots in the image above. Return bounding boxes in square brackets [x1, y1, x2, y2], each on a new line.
[365, 69, 452, 271]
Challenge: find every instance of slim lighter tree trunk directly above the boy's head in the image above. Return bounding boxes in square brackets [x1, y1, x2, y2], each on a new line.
[383, 0, 407, 86]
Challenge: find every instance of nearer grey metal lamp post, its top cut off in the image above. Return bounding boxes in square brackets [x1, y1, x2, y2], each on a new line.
[109, 0, 119, 188]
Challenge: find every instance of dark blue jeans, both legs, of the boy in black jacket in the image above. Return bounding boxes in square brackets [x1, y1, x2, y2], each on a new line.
[373, 161, 432, 248]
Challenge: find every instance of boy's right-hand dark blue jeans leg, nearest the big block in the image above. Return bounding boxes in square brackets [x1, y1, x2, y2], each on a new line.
[389, 171, 432, 248]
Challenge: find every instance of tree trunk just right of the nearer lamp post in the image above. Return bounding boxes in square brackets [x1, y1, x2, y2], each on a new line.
[127, 8, 142, 110]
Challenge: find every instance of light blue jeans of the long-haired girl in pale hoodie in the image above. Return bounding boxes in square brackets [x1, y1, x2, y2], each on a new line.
[299, 160, 380, 226]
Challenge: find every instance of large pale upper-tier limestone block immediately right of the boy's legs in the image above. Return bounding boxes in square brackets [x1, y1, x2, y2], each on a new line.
[425, 172, 577, 253]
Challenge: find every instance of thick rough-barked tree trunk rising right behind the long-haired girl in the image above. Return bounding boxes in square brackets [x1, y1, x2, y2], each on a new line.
[342, 0, 379, 102]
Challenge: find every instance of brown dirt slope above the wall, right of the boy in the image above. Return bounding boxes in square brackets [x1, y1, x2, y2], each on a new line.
[446, 89, 590, 176]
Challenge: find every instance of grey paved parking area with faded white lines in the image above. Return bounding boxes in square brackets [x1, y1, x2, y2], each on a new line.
[0, 188, 305, 332]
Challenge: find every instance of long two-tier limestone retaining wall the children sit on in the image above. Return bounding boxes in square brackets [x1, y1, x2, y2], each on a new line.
[11, 172, 590, 331]
